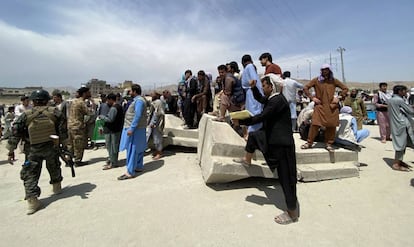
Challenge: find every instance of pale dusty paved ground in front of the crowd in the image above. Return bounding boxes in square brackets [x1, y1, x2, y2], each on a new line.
[0, 126, 414, 247]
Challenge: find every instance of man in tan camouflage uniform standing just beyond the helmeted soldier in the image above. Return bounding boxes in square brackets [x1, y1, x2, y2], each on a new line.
[68, 87, 91, 166]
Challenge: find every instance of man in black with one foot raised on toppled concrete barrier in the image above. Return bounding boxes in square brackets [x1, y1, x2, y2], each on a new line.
[233, 76, 299, 225]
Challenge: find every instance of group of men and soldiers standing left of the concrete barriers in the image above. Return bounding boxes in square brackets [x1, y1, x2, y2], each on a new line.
[5, 84, 168, 214]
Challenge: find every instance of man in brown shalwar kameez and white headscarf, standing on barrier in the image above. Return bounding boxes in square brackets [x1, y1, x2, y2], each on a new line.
[301, 64, 348, 152]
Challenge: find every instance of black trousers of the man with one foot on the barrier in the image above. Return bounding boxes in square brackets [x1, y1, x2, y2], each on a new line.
[245, 130, 298, 210]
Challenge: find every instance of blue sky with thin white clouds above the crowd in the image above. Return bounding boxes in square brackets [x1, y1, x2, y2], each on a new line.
[0, 0, 414, 88]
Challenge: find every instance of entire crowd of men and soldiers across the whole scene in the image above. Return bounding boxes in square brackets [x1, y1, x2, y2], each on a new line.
[3, 53, 414, 224]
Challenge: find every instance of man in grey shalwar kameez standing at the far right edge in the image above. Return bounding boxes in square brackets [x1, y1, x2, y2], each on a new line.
[388, 85, 414, 171]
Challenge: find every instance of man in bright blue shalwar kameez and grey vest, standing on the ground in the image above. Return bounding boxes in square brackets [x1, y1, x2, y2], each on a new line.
[118, 84, 147, 180]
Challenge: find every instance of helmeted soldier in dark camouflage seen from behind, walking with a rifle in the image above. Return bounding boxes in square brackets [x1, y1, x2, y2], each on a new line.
[7, 89, 66, 214]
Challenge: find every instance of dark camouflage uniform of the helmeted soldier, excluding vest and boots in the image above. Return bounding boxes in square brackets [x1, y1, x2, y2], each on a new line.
[7, 106, 67, 199]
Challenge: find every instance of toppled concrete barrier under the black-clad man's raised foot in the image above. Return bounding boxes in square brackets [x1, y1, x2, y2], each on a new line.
[197, 116, 359, 183]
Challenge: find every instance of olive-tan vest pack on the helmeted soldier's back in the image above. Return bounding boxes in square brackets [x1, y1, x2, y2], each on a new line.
[26, 107, 57, 144]
